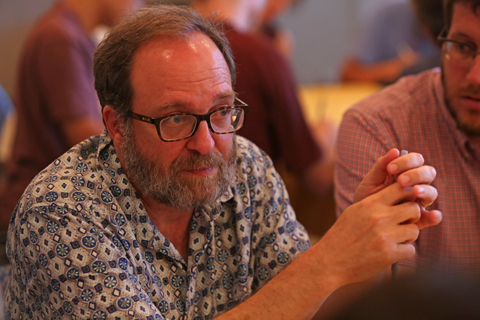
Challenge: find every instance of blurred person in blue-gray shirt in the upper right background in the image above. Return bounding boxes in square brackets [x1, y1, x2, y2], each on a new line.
[341, 0, 443, 84]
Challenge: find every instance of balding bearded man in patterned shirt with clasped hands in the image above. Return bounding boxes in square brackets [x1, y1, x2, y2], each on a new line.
[6, 6, 441, 319]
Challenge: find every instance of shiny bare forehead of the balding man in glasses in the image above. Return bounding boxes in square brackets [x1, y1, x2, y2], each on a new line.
[131, 32, 231, 109]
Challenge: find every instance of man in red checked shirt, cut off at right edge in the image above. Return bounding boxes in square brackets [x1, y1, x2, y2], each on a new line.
[335, 0, 480, 276]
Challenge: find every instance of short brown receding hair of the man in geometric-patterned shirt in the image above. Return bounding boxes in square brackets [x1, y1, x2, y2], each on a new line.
[93, 5, 235, 117]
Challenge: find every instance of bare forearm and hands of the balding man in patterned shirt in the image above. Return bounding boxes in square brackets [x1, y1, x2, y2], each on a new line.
[218, 150, 441, 319]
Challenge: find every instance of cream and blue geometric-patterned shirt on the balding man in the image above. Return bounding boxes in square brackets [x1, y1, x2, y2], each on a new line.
[6, 131, 310, 320]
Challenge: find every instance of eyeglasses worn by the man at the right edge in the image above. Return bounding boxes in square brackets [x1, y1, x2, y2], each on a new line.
[437, 28, 480, 68]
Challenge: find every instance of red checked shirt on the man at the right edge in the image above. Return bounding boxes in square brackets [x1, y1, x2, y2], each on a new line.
[335, 69, 480, 274]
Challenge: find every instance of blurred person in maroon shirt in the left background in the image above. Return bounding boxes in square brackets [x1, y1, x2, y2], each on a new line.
[0, 0, 145, 230]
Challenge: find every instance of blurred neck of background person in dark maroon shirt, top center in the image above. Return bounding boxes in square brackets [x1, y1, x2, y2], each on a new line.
[193, 0, 253, 32]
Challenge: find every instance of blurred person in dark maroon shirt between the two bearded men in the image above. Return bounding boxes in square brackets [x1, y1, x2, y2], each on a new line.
[192, 0, 336, 200]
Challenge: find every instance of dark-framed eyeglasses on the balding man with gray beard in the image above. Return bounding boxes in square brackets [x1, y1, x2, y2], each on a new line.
[127, 98, 248, 142]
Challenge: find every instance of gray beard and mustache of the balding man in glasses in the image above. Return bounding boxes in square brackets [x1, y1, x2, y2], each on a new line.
[121, 120, 236, 210]
